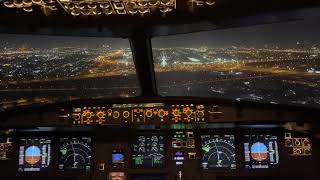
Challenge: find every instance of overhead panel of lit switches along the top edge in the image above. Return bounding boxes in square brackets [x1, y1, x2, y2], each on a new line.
[4, 0, 176, 16]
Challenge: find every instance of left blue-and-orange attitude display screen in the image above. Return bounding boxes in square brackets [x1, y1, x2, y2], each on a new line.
[18, 138, 51, 172]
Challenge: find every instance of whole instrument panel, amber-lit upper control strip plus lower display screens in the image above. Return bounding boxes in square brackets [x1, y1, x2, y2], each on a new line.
[0, 103, 319, 180]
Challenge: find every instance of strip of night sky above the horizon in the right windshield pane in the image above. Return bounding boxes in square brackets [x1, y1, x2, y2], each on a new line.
[152, 19, 320, 48]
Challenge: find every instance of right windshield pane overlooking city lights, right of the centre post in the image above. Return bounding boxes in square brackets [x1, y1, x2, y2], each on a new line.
[152, 19, 320, 107]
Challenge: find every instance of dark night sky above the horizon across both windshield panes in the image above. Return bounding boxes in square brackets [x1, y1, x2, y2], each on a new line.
[0, 18, 320, 48]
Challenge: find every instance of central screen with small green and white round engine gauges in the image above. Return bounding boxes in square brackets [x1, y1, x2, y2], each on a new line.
[132, 134, 165, 168]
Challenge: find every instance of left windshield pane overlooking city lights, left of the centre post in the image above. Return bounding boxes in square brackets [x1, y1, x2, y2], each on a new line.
[0, 34, 140, 108]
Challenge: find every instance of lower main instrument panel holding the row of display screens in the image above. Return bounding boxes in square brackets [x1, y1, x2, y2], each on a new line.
[0, 128, 312, 180]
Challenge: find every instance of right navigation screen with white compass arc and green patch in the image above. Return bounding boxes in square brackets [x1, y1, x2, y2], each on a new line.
[201, 135, 236, 169]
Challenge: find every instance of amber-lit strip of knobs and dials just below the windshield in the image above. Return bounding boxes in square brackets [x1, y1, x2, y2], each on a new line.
[71, 103, 211, 125]
